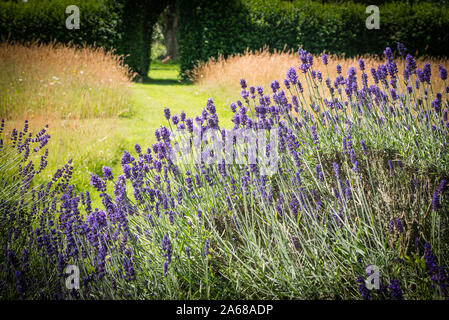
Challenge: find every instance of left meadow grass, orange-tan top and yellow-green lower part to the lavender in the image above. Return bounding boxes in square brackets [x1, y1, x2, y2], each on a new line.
[0, 42, 133, 205]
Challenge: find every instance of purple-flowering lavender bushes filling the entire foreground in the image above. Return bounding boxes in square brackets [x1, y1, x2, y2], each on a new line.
[0, 45, 449, 299]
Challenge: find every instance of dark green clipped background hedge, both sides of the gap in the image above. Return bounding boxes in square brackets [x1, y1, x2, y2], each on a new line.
[0, 0, 449, 77]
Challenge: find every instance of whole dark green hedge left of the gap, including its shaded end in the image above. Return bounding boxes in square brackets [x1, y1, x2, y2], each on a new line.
[0, 0, 167, 77]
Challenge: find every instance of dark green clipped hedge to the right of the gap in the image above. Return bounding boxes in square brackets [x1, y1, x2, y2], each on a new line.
[178, 0, 449, 75]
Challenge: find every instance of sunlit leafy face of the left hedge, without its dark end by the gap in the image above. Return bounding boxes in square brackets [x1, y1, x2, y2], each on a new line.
[0, 0, 122, 48]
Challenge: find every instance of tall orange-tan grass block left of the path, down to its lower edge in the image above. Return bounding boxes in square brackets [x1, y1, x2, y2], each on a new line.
[0, 42, 134, 119]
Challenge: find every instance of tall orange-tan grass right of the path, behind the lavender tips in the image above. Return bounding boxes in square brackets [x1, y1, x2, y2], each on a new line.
[192, 48, 449, 109]
